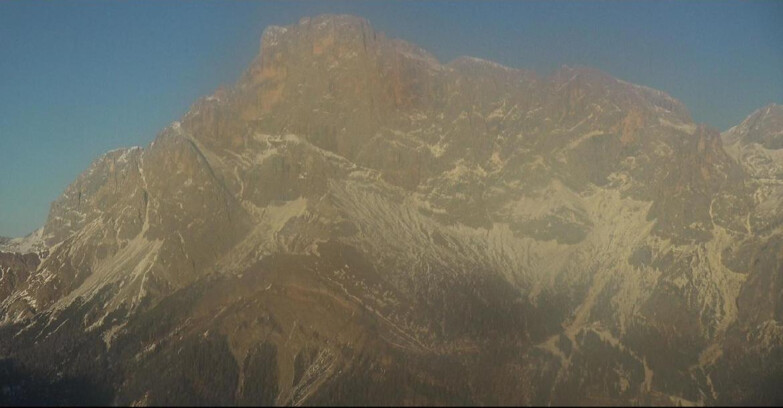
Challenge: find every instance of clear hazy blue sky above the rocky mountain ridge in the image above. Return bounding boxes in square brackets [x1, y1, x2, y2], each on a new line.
[0, 1, 783, 236]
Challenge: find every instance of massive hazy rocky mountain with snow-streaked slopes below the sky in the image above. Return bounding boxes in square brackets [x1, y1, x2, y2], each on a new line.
[0, 15, 783, 405]
